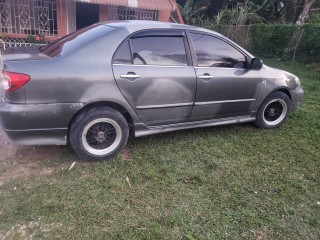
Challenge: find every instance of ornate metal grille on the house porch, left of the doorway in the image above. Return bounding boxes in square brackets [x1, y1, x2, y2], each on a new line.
[0, 0, 58, 36]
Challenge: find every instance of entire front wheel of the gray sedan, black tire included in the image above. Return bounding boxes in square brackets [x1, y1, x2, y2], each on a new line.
[255, 92, 291, 129]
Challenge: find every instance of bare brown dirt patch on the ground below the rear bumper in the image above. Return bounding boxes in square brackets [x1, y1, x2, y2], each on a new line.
[0, 126, 68, 186]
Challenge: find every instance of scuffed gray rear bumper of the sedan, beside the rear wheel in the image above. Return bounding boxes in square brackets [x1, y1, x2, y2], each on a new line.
[0, 103, 83, 145]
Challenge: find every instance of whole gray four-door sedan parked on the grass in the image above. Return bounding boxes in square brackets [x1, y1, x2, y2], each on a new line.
[0, 21, 303, 160]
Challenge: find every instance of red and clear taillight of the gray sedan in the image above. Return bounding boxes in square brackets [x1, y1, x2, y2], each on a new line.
[1, 71, 30, 92]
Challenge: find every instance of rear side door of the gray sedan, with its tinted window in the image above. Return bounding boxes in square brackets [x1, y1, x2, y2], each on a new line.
[113, 30, 196, 126]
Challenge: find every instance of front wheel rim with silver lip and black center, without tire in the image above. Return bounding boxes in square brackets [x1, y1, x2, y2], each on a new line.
[263, 99, 288, 126]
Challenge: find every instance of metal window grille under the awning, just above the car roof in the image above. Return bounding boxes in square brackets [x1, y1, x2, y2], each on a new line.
[108, 6, 159, 21]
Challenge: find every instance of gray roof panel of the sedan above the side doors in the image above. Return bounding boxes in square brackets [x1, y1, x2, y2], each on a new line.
[102, 20, 222, 36]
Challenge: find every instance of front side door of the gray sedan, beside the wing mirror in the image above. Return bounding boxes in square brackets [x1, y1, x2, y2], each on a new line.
[189, 32, 261, 121]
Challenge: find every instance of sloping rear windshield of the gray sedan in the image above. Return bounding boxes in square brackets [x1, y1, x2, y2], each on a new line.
[40, 24, 114, 57]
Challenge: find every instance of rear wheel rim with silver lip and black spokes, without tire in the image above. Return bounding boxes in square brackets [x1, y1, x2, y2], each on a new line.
[82, 118, 122, 156]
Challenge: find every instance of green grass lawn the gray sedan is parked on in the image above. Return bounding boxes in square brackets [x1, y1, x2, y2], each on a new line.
[0, 61, 320, 239]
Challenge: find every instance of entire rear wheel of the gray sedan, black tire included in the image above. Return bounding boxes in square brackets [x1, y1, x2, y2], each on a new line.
[69, 107, 129, 161]
